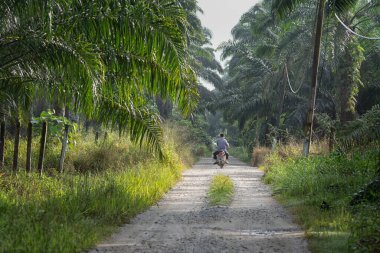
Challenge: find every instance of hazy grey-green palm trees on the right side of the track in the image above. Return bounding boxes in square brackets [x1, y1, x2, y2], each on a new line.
[217, 0, 380, 151]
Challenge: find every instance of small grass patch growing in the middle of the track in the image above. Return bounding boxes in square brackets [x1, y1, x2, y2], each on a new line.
[208, 174, 234, 206]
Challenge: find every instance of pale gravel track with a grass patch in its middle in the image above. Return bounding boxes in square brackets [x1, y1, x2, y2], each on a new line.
[90, 158, 309, 253]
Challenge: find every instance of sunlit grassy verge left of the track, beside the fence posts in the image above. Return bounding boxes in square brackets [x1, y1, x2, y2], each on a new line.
[0, 126, 196, 252]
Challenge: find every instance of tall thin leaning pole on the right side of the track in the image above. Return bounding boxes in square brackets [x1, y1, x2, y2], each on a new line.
[303, 0, 325, 156]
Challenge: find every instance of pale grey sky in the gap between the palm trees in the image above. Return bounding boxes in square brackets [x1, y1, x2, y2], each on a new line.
[198, 0, 258, 58]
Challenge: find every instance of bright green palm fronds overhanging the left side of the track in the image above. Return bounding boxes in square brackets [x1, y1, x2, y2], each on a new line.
[0, 0, 221, 170]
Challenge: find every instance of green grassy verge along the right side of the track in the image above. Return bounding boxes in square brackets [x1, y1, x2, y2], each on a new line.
[262, 144, 380, 252]
